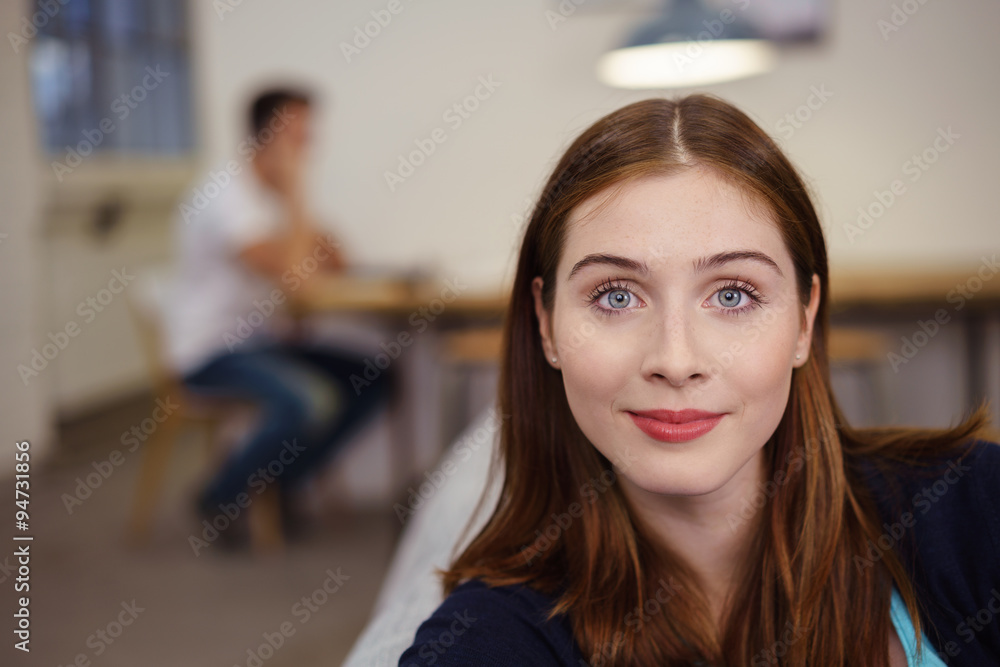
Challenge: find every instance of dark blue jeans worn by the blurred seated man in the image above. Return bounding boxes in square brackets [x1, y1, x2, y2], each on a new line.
[183, 343, 391, 514]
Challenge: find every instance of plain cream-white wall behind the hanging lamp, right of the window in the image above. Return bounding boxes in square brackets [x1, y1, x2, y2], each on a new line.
[195, 0, 1000, 286]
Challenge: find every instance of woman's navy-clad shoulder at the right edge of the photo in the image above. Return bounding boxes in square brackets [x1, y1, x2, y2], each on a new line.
[854, 440, 1000, 664]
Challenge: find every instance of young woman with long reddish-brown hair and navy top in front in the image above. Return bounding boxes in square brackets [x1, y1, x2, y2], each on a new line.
[400, 95, 1000, 667]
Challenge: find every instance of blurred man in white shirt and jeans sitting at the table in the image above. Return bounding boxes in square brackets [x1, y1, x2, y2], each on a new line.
[166, 90, 388, 537]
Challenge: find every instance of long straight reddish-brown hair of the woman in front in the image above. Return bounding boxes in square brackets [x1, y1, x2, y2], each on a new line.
[444, 95, 987, 667]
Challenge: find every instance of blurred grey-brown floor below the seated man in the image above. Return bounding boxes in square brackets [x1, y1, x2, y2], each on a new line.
[8, 401, 398, 667]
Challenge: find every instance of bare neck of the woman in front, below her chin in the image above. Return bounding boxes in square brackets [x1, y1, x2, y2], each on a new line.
[623, 450, 765, 623]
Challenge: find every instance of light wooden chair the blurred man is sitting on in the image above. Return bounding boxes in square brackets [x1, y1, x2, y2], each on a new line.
[128, 271, 284, 551]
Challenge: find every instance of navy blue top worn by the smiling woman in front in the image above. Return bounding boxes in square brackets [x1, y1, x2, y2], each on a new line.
[399, 441, 1000, 667]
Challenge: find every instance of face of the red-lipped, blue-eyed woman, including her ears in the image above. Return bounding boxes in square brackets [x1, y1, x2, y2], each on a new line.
[534, 167, 819, 504]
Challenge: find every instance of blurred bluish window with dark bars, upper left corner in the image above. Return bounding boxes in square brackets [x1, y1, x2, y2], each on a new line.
[29, 0, 194, 159]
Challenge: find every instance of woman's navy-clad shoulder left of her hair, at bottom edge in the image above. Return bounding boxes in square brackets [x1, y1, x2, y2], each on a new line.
[399, 579, 582, 667]
